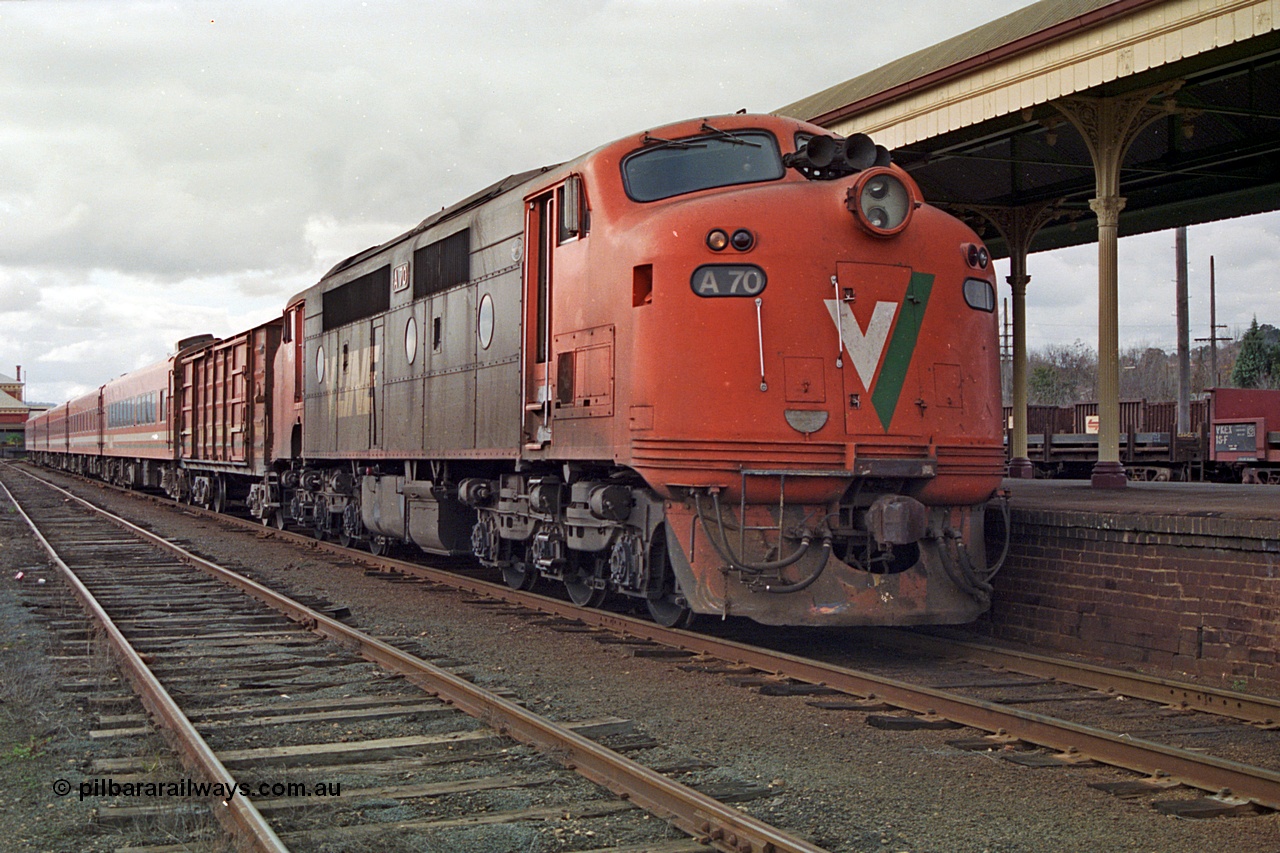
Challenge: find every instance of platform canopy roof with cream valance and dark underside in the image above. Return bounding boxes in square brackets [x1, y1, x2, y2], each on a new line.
[777, 0, 1280, 256]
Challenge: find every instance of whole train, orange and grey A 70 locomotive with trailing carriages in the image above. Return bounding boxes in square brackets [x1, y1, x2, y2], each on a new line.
[27, 115, 1007, 625]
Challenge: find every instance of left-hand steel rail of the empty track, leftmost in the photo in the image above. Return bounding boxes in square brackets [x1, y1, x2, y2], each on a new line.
[0, 483, 289, 853]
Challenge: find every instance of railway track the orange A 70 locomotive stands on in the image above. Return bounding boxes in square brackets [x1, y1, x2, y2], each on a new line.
[12, 461, 1280, 816]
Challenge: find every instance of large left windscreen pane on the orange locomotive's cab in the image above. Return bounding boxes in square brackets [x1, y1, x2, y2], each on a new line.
[622, 131, 785, 201]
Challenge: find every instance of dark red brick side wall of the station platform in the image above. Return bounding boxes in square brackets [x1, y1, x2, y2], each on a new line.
[978, 504, 1280, 688]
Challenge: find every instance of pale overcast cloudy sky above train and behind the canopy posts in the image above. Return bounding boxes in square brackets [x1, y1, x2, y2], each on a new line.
[0, 0, 1280, 402]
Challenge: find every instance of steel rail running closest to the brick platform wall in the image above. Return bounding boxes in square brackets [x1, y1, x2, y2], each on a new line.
[876, 631, 1280, 724]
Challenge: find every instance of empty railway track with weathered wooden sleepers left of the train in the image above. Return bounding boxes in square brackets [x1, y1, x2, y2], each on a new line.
[0, 467, 819, 853]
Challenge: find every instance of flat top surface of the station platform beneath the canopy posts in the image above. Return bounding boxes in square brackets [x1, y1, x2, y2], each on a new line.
[1004, 479, 1280, 521]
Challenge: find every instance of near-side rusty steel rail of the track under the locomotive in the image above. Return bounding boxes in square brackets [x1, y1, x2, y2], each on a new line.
[20, 461, 1280, 809]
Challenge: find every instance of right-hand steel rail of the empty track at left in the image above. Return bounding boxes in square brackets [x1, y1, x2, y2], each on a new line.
[5, 474, 824, 853]
